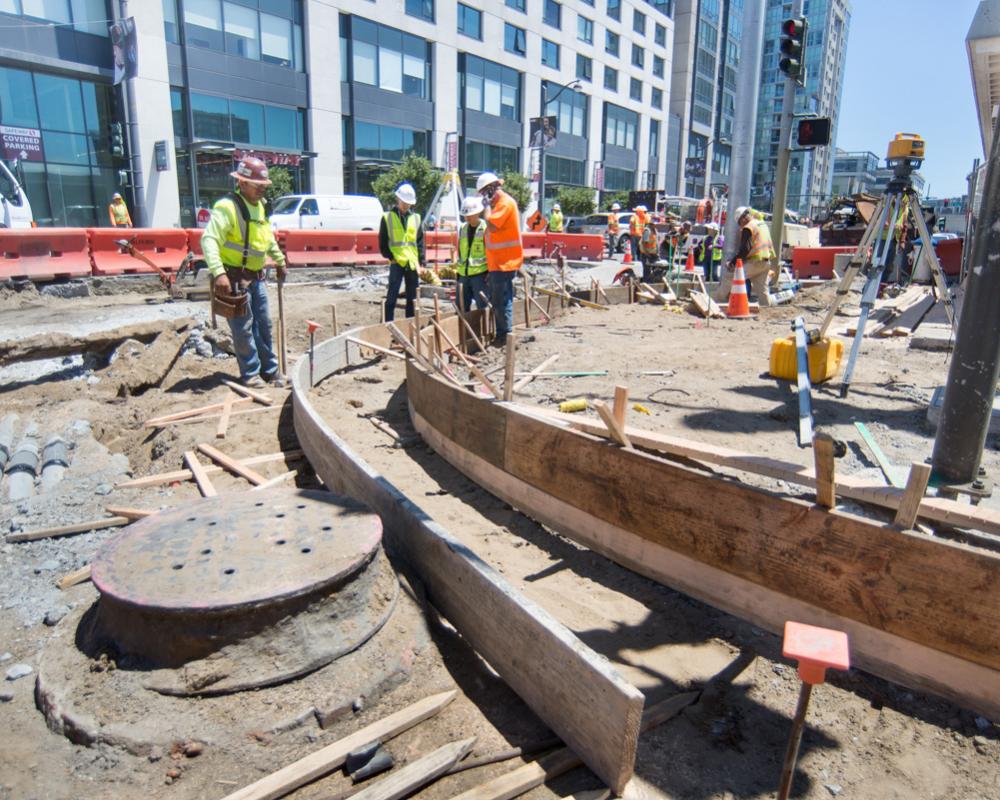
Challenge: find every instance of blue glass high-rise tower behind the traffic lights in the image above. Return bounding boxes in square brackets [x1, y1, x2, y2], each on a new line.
[751, 0, 851, 216]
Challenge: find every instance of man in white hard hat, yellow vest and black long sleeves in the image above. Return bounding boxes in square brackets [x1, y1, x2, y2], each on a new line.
[378, 183, 424, 322]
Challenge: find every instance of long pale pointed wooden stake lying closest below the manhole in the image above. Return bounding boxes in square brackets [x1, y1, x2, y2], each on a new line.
[223, 690, 458, 800]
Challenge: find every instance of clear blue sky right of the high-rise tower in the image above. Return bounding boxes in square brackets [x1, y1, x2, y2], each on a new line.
[836, 0, 983, 197]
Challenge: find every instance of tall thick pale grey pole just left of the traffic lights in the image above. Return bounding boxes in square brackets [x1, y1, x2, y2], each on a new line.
[725, 0, 764, 260]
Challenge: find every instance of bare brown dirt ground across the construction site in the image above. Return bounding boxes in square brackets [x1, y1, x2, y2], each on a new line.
[0, 270, 1000, 800]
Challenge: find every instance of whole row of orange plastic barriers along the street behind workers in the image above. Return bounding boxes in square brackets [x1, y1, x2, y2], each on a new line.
[0, 228, 604, 281]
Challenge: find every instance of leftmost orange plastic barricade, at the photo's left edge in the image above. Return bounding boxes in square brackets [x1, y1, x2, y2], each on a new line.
[0, 228, 90, 281]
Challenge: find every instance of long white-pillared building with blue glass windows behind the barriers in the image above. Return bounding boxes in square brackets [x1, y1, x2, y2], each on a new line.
[0, 0, 677, 226]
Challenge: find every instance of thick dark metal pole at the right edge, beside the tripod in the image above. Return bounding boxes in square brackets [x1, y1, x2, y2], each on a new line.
[928, 115, 1000, 488]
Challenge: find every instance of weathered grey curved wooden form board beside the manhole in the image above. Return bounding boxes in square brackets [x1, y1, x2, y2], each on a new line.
[292, 326, 643, 793]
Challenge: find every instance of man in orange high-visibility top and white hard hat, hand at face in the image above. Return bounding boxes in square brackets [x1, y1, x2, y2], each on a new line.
[476, 172, 524, 347]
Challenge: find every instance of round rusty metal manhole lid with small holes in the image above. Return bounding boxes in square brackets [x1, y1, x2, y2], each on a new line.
[91, 489, 382, 612]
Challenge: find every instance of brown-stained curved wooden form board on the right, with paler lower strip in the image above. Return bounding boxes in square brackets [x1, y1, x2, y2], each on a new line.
[407, 365, 1000, 714]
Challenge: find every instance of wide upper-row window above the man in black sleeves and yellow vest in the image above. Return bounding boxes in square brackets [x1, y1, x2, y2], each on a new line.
[351, 17, 430, 100]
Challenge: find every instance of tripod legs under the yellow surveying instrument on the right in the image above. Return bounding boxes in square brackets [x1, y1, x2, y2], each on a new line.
[810, 157, 955, 397]
